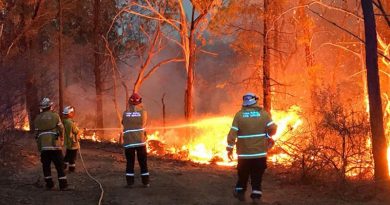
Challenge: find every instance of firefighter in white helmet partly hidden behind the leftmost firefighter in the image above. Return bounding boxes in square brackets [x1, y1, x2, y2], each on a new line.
[62, 106, 80, 172]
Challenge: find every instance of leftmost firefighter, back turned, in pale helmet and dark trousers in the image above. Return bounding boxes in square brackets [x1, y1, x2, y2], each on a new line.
[34, 98, 70, 191]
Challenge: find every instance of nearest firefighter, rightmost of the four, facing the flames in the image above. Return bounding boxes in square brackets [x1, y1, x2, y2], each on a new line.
[226, 93, 277, 202]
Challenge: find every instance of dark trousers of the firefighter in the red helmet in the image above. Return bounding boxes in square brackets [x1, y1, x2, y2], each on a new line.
[125, 146, 149, 185]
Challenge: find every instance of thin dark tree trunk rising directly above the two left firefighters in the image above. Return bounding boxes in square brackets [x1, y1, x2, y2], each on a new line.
[58, 0, 65, 113]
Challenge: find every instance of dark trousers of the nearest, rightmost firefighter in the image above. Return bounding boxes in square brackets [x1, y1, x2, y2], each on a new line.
[235, 157, 267, 198]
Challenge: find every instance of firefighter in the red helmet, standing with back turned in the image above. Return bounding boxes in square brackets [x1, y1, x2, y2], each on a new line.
[122, 93, 150, 187]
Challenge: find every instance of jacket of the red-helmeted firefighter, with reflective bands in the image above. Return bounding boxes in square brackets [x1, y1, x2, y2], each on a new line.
[122, 104, 147, 148]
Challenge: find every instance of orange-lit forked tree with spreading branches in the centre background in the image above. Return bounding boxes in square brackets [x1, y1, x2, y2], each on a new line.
[123, 0, 219, 121]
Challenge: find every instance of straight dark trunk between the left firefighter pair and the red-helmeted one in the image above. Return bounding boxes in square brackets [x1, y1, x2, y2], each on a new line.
[93, 0, 103, 128]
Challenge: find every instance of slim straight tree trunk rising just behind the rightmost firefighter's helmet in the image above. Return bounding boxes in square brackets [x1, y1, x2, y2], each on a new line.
[262, 0, 271, 113]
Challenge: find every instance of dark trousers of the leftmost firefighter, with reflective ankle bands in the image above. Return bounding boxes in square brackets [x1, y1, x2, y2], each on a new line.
[41, 150, 68, 189]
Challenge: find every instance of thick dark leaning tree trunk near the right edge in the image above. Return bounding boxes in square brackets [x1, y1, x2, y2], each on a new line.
[361, 0, 389, 182]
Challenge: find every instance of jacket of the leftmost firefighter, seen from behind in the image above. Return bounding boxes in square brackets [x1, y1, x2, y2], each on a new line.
[34, 110, 64, 151]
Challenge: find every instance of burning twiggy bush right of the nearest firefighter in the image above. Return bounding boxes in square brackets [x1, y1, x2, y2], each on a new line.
[272, 89, 373, 181]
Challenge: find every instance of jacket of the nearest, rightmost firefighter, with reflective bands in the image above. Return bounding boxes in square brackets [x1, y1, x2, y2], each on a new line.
[227, 104, 277, 159]
